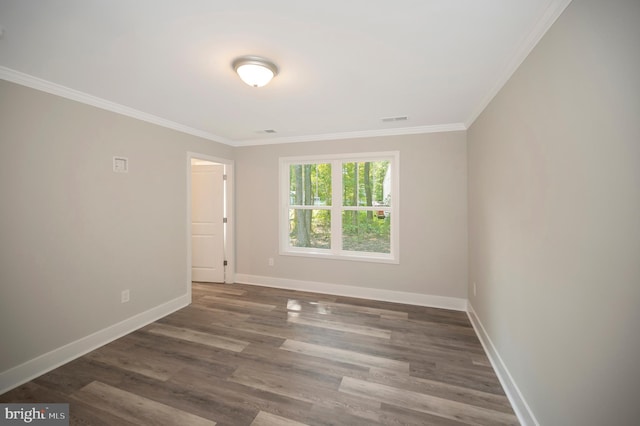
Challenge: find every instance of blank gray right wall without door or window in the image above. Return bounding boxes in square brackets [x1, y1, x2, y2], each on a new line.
[468, 0, 640, 425]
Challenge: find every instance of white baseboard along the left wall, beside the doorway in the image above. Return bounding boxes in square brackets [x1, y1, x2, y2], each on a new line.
[0, 294, 191, 394]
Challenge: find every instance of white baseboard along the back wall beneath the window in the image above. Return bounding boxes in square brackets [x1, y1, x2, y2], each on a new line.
[235, 273, 467, 311]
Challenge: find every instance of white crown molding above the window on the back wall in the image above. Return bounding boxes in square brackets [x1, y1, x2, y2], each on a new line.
[232, 123, 467, 147]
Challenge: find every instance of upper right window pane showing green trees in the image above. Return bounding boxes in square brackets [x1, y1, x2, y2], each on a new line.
[342, 161, 391, 207]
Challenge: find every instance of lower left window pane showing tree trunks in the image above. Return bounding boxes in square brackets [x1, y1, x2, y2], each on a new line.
[289, 209, 331, 249]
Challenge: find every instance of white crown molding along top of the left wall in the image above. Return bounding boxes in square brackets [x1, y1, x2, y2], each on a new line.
[0, 66, 232, 145]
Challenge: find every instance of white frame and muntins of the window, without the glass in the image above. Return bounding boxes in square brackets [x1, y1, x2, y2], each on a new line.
[279, 151, 400, 264]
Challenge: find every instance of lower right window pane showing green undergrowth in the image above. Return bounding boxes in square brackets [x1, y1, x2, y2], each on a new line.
[342, 210, 391, 253]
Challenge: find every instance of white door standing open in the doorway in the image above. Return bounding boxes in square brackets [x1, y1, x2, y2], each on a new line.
[191, 164, 224, 283]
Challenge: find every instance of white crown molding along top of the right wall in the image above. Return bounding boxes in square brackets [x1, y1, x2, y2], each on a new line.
[465, 0, 571, 129]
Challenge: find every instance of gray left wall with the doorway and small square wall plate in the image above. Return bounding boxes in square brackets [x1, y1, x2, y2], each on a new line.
[0, 80, 233, 372]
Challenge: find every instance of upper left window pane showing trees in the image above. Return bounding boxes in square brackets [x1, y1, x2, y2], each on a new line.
[289, 163, 331, 206]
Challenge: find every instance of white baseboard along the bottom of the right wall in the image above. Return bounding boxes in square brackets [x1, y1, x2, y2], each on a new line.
[467, 302, 540, 426]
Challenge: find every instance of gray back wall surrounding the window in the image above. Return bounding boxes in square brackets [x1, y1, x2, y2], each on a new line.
[236, 132, 467, 298]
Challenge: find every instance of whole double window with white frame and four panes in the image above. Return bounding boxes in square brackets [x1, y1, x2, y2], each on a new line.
[280, 152, 399, 263]
